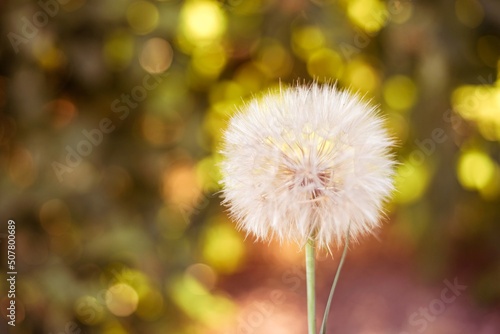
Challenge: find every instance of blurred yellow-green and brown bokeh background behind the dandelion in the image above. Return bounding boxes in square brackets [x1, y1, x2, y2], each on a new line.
[0, 0, 500, 334]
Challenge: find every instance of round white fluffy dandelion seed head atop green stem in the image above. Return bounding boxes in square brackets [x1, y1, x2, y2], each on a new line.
[221, 84, 395, 247]
